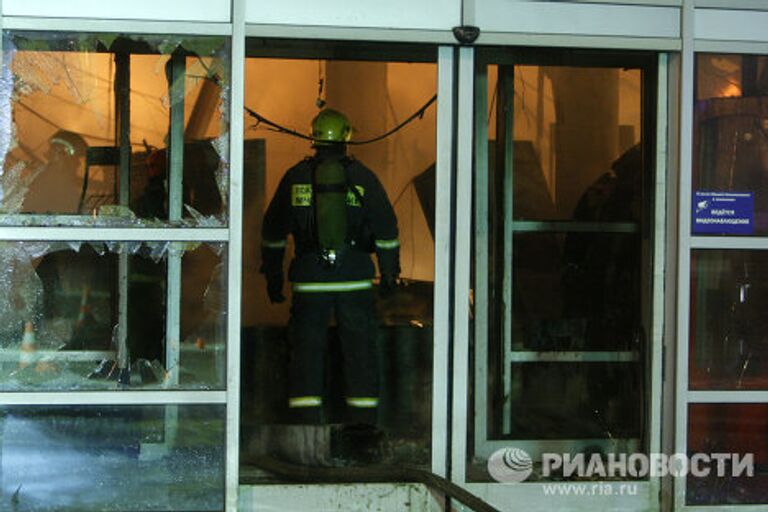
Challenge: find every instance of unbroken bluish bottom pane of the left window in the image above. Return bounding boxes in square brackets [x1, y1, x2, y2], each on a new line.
[0, 405, 226, 512]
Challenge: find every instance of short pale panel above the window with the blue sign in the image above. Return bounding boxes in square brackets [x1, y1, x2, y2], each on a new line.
[694, 9, 768, 42]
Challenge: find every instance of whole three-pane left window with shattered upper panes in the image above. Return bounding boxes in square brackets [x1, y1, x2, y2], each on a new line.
[0, 32, 230, 511]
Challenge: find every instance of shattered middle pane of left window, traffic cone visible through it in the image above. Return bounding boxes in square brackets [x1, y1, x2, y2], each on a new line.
[0, 242, 227, 391]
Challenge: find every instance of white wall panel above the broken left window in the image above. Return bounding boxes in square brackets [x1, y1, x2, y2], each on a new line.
[2, 0, 231, 23]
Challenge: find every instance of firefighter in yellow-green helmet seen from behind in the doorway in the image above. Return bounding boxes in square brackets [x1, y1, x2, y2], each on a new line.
[261, 109, 400, 425]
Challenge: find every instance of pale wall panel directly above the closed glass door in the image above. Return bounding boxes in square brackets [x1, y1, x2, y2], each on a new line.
[474, 0, 680, 38]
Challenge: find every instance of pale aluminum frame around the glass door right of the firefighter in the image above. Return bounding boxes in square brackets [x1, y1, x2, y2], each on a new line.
[450, 47, 669, 511]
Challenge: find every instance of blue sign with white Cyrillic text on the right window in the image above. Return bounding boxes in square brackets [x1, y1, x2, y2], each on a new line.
[692, 192, 755, 235]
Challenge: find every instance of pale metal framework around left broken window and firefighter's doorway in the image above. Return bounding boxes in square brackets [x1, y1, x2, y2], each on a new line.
[0, 13, 455, 511]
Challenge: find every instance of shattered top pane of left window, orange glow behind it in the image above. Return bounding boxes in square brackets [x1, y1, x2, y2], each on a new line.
[0, 31, 230, 227]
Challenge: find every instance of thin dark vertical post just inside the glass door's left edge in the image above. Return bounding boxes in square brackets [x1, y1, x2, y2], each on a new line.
[496, 66, 515, 434]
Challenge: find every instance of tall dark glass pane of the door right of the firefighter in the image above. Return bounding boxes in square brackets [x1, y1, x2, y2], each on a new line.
[466, 50, 661, 506]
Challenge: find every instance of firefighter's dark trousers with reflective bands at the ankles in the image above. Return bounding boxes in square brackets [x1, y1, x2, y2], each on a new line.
[289, 290, 379, 423]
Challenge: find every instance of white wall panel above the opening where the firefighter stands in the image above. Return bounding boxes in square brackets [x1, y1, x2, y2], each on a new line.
[245, 0, 461, 30]
